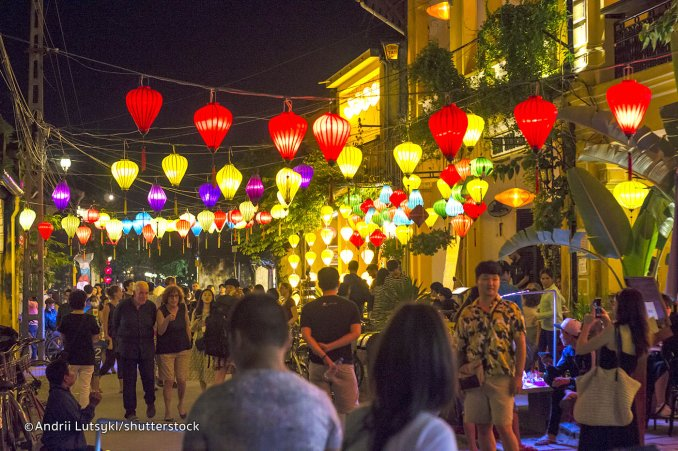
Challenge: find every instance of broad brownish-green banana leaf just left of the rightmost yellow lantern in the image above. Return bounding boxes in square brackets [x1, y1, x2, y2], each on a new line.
[567, 167, 632, 259]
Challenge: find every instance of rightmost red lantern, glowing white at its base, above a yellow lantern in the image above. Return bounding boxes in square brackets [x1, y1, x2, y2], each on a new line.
[605, 79, 652, 139]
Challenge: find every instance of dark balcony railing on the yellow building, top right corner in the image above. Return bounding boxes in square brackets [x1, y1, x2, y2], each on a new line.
[614, 0, 671, 78]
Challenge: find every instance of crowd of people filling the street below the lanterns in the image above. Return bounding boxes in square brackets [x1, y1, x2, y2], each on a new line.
[29, 254, 672, 451]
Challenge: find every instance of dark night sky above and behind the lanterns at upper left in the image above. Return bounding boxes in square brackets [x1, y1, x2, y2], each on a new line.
[0, 0, 402, 212]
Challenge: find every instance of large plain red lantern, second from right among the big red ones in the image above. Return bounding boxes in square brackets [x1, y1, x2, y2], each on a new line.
[513, 96, 558, 152]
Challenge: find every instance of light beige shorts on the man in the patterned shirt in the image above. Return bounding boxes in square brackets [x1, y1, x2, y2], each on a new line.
[464, 376, 514, 426]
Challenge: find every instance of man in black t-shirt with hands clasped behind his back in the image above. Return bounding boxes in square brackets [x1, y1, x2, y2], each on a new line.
[300, 267, 360, 415]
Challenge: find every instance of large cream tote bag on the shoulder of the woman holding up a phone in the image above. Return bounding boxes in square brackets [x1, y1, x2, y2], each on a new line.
[574, 326, 640, 426]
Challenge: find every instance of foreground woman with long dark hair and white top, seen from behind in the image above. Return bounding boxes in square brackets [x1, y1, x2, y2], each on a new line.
[344, 304, 457, 451]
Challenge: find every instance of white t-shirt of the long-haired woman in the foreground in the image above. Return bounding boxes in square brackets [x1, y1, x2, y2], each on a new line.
[344, 406, 457, 451]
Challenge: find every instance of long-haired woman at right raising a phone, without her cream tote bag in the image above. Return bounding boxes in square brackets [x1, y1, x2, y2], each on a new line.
[577, 288, 650, 451]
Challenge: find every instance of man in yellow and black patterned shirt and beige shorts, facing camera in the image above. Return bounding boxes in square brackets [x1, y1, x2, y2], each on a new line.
[456, 261, 525, 451]
